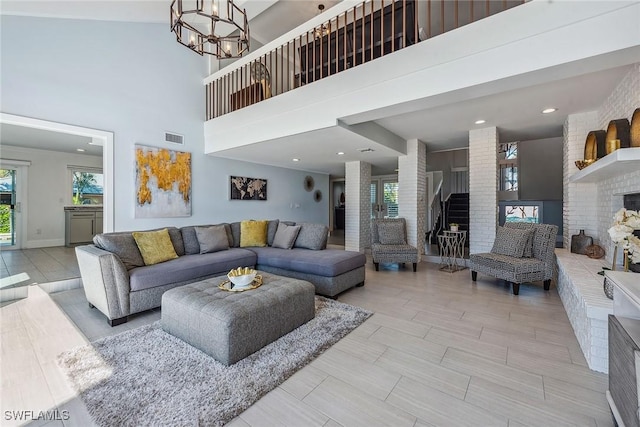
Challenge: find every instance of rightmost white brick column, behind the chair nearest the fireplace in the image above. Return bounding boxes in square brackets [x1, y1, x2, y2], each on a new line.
[469, 127, 498, 253]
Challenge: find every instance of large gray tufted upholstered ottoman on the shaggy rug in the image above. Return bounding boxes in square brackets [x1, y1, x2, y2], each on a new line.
[161, 272, 315, 365]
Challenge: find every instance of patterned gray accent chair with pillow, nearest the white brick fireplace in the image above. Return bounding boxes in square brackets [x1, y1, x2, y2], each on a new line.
[469, 222, 558, 295]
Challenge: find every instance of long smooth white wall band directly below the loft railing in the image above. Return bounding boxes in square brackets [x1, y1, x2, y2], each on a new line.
[205, 1, 640, 153]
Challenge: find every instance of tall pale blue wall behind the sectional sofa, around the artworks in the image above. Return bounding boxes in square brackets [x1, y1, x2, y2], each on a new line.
[0, 15, 329, 234]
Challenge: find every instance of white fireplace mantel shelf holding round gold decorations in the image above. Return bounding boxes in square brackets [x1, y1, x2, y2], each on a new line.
[569, 147, 640, 182]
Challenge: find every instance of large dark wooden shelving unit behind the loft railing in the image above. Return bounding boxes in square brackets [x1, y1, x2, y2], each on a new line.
[296, 0, 416, 85]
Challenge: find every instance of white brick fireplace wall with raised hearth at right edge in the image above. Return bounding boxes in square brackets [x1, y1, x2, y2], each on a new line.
[556, 64, 640, 372]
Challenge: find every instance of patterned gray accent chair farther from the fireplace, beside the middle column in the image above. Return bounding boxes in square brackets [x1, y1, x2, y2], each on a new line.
[371, 218, 419, 272]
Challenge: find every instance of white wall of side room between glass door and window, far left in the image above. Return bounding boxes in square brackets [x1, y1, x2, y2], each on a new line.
[2, 145, 102, 248]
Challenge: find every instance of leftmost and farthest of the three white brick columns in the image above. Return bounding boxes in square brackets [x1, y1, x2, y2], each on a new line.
[344, 161, 371, 252]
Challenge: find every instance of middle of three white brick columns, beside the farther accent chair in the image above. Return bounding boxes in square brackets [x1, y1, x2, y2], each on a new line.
[398, 139, 427, 254]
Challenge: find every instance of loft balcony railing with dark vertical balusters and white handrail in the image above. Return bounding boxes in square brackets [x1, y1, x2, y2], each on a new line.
[205, 0, 527, 120]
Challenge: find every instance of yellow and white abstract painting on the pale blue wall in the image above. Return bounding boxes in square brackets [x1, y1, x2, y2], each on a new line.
[135, 144, 191, 218]
